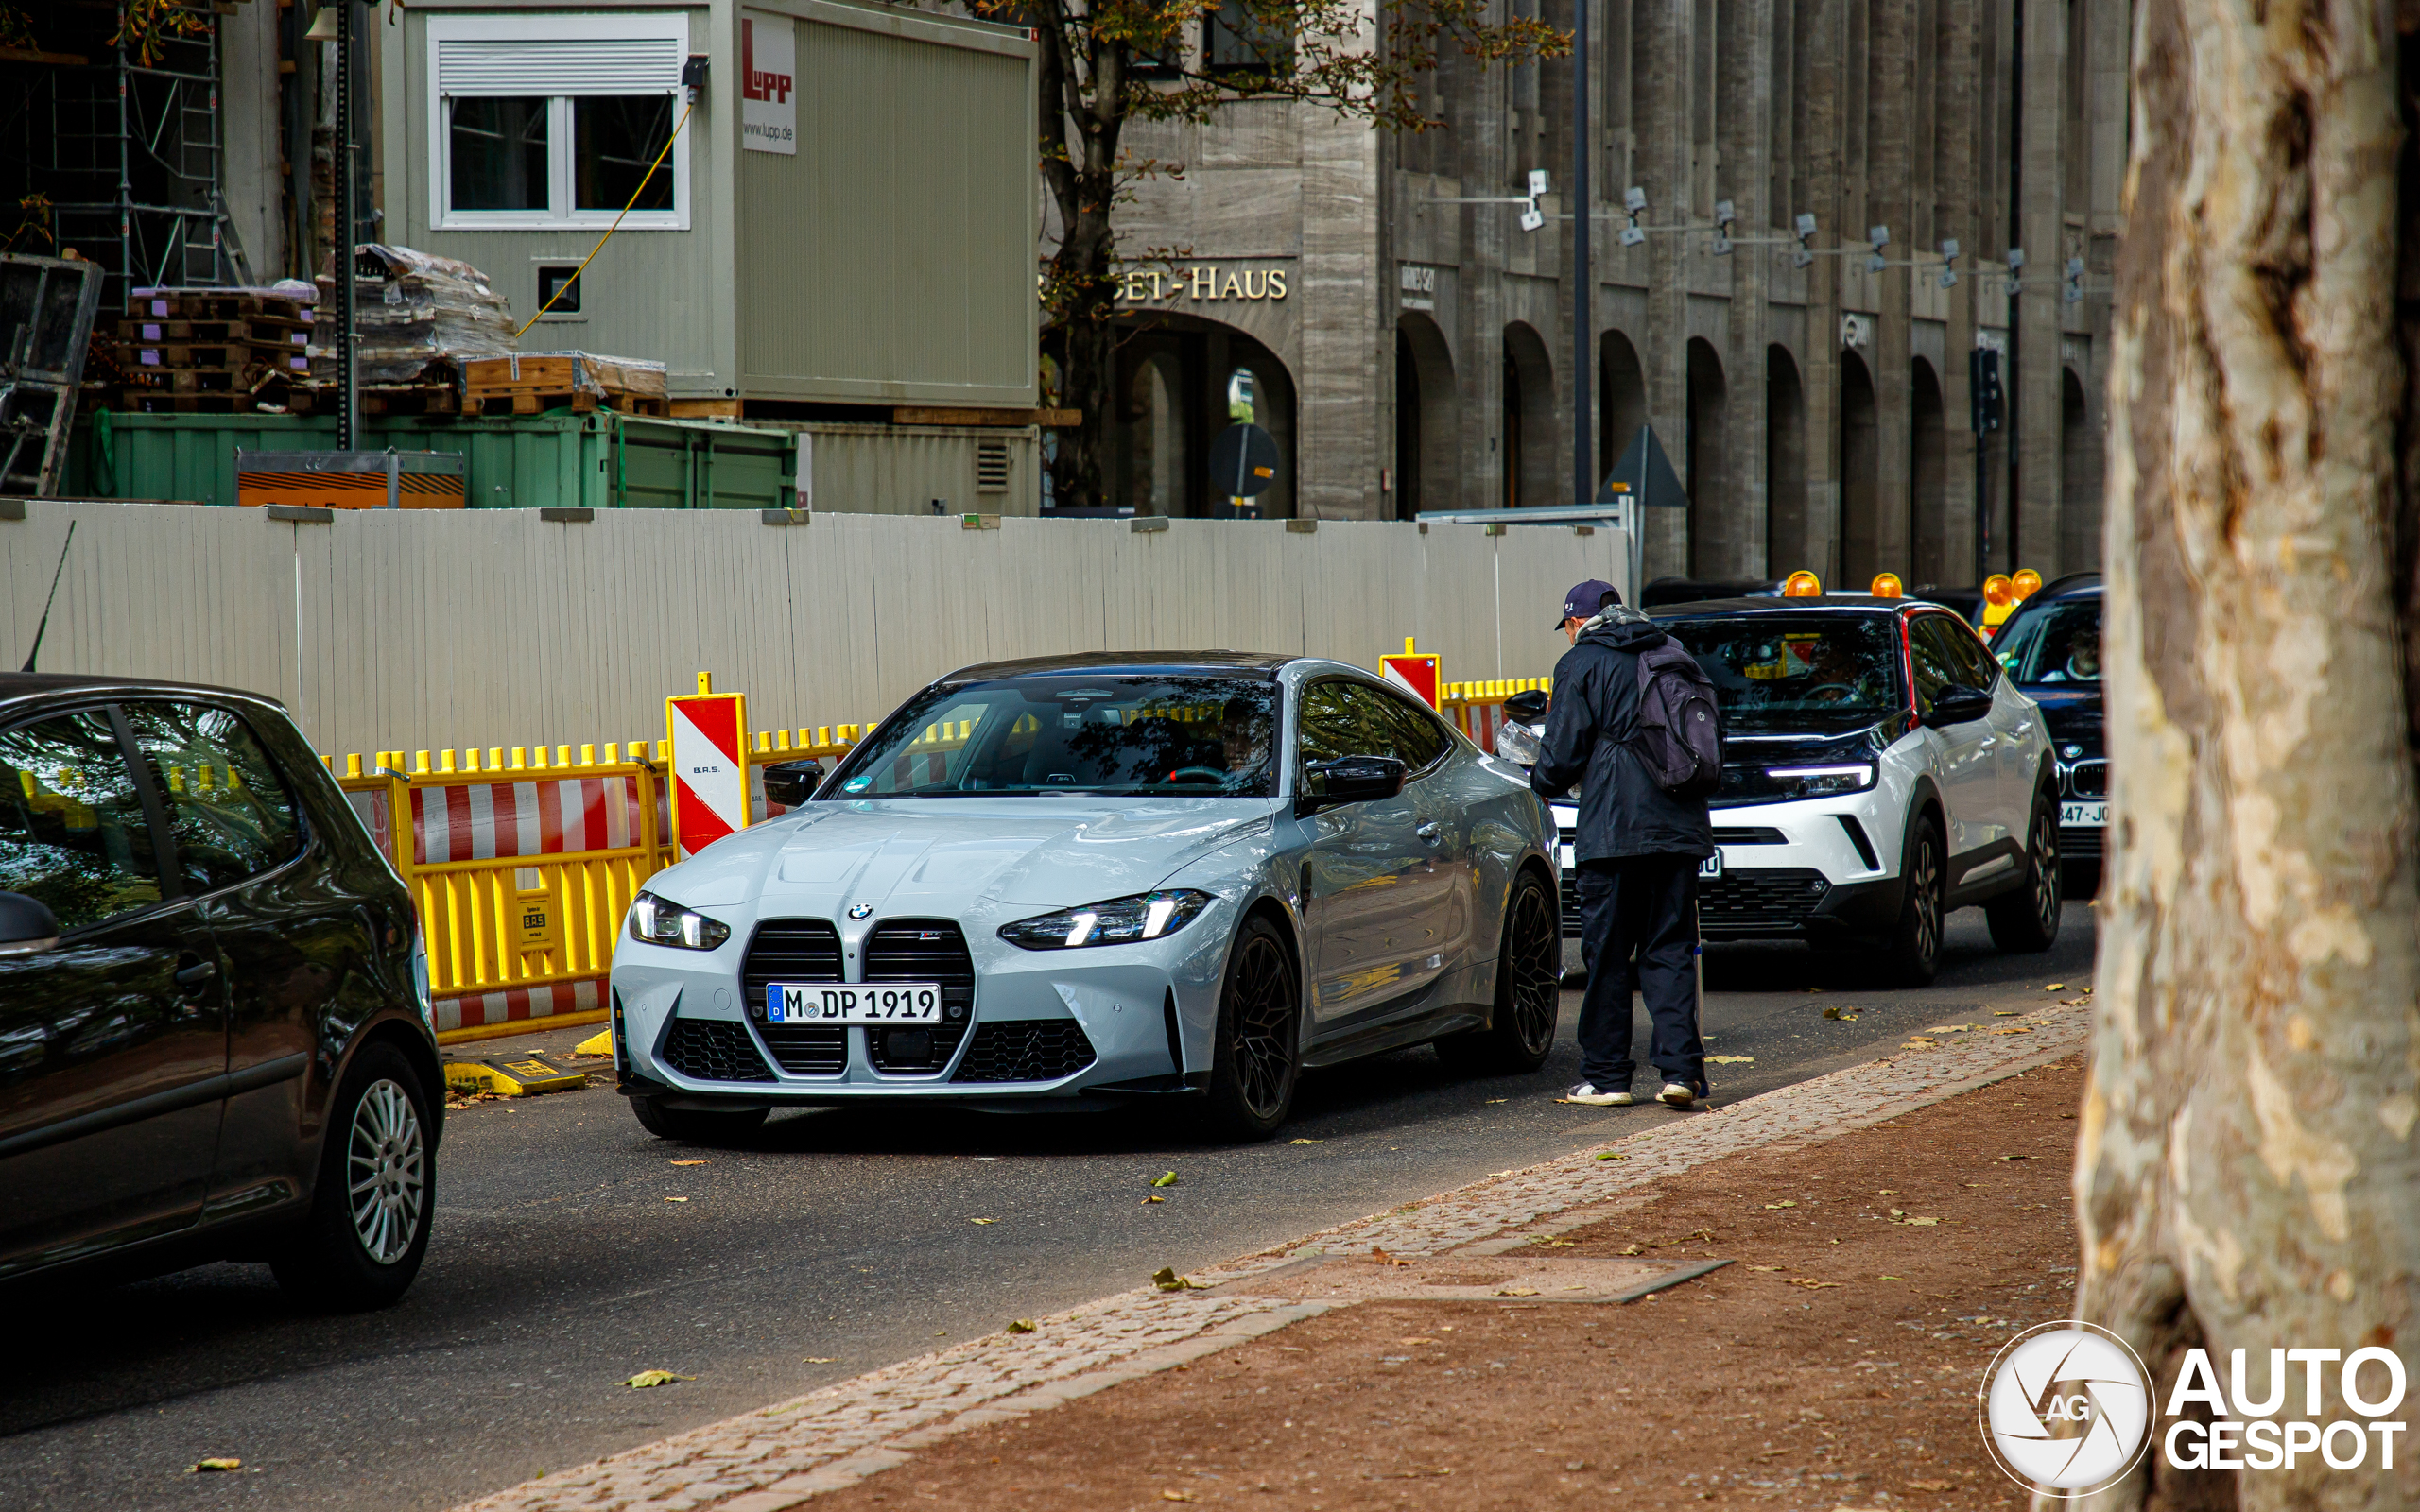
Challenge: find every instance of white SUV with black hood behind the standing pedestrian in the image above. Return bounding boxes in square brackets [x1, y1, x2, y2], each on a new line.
[1498, 597, 2060, 985]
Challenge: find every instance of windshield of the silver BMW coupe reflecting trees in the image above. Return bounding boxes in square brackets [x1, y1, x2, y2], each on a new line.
[825, 673, 1278, 799]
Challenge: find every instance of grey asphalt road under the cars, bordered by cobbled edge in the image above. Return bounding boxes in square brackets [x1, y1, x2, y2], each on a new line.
[0, 904, 2093, 1512]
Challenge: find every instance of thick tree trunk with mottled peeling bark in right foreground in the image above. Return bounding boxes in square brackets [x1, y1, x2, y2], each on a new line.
[2081, 0, 2420, 1509]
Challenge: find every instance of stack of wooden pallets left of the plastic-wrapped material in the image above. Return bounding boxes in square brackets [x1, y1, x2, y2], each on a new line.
[101, 288, 310, 414]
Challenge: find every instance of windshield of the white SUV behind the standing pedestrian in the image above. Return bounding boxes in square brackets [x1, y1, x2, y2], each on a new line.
[1665, 614, 1907, 730]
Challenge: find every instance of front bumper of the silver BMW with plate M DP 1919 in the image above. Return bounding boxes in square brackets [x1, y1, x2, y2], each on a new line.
[613, 900, 1239, 1108]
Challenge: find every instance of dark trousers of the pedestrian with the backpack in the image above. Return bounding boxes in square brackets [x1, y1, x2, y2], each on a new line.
[1573, 856, 1706, 1096]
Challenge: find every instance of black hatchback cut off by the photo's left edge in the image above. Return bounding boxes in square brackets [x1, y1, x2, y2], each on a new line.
[0, 675, 442, 1309]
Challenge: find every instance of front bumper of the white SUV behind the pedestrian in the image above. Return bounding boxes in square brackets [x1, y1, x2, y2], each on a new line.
[1554, 789, 1905, 943]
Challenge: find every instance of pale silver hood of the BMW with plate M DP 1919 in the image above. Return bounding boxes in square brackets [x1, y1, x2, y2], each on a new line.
[648, 799, 1278, 917]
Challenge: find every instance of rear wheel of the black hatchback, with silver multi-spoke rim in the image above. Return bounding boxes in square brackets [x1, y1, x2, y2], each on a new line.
[268, 1045, 438, 1312]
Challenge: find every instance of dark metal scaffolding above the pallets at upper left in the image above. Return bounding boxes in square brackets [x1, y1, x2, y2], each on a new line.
[0, 0, 251, 310]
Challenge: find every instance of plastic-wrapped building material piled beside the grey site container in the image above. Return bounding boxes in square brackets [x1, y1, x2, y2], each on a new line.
[312, 245, 515, 385]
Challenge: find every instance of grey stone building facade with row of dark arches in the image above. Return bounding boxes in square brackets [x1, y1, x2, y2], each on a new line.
[1115, 0, 2130, 586]
